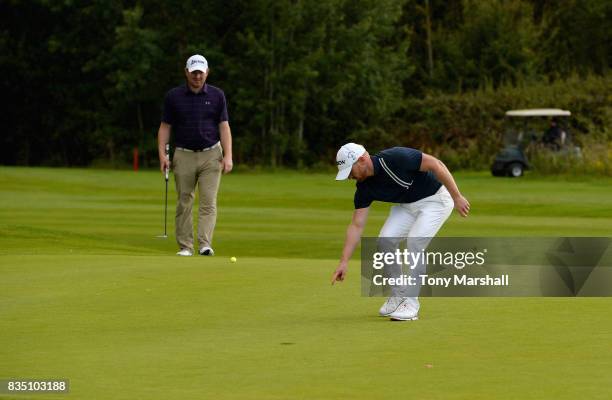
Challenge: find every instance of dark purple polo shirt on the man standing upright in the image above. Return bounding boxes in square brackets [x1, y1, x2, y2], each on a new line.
[162, 84, 228, 150]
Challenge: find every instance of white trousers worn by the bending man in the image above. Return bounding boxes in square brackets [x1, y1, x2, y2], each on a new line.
[378, 186, 454, 310]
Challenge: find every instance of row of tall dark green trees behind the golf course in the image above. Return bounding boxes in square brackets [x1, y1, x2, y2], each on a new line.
[0, 0, 612, 166]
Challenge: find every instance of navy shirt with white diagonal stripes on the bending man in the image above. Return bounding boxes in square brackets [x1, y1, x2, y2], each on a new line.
[354, 147, 442, 209]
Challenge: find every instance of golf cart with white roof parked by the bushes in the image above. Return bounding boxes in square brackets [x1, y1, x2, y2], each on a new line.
[491, 108, 580, 178]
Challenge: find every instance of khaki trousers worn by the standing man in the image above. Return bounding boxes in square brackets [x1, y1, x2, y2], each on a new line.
[172, 146, 223, 251]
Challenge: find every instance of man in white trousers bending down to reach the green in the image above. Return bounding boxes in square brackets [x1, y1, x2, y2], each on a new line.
[332, 143, 470, 321]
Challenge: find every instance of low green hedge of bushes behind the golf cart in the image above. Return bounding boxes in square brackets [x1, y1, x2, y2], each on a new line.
[382, 76, 612, 174]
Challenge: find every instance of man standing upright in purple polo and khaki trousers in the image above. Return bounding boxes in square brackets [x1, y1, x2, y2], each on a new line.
[157, 54, 233, 256]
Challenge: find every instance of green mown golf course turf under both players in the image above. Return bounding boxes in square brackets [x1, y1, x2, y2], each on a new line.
[0, 167, 612, 399]
